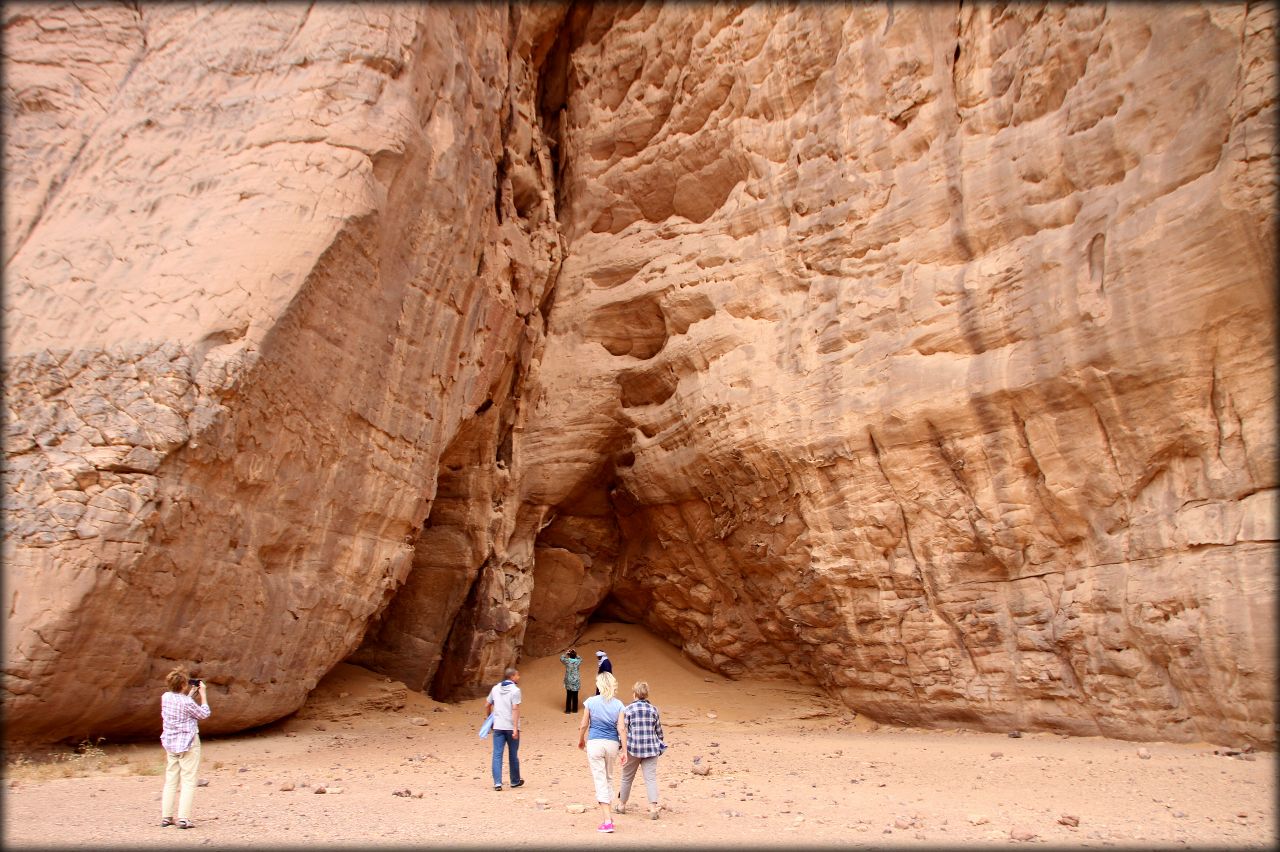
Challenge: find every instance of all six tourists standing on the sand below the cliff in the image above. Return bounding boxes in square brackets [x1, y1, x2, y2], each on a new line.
[160, 649, 667, 833]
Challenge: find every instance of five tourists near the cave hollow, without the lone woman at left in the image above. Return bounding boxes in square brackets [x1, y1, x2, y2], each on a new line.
[481, 649, 667, 834]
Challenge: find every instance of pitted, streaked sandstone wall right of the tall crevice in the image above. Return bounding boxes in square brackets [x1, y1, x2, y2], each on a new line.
[514, 4, 1276, 741]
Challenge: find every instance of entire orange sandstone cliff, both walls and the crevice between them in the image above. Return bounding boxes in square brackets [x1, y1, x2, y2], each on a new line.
[4, 4, 1277, 743]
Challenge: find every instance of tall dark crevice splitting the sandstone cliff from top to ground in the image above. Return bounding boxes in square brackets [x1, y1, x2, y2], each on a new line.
[351, 4, 573, 701]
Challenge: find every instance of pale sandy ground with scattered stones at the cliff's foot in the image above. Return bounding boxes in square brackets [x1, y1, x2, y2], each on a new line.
[4, 624, 1276, 848]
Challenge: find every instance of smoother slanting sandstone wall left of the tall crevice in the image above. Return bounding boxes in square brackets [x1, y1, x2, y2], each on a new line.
[4, 4, 559, 739]
